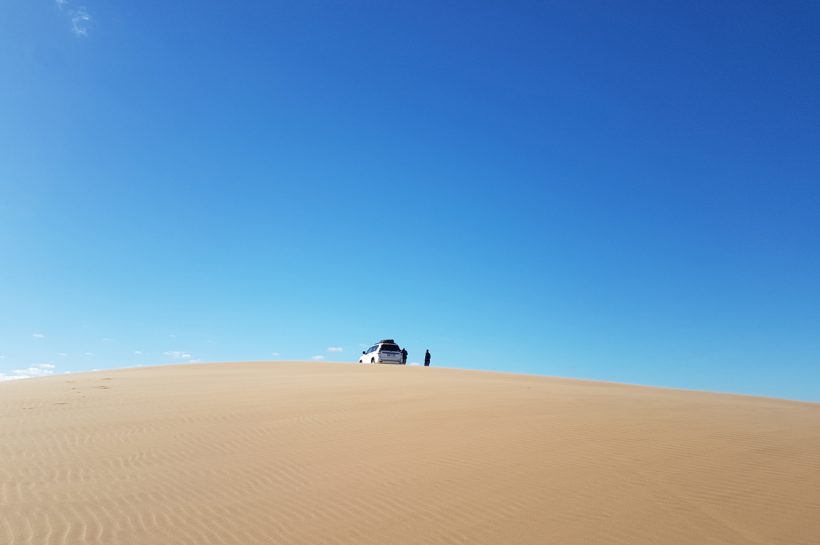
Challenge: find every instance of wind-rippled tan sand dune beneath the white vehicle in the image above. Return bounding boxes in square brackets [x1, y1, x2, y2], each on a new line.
[0, 363, 820, 545]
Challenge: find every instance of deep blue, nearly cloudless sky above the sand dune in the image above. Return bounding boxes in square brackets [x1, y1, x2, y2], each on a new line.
[0, 0, 820, 401]
